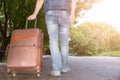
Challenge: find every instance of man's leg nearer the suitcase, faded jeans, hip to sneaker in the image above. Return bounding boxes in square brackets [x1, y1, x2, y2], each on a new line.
[46, 11, 62, 76]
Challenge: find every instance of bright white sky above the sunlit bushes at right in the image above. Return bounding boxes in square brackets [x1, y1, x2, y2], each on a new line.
[76, 0, 120, 31]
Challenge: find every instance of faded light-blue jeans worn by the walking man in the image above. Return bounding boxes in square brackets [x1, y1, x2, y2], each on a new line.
[45, 10, 69, 71]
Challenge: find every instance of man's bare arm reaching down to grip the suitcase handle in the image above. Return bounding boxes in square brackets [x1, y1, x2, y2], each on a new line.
[27, 0, 44, 20]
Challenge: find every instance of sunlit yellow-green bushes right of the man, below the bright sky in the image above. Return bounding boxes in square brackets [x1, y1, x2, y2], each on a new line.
[70, 22, 120, 55]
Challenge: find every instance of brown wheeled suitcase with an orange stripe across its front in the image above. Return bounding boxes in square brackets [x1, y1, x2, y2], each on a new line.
[6, 19, 43, 76]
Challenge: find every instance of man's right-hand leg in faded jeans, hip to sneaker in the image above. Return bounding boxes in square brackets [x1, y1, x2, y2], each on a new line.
[59, 11, 70, 72]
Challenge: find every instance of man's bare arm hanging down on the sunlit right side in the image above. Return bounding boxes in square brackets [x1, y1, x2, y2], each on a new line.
[70, 0, 76, 24]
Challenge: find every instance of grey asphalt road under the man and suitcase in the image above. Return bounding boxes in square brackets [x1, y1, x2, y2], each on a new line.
[0, 56, 120, 80]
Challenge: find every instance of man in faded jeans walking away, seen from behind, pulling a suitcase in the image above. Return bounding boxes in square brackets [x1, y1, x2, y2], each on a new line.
[27, 0, 76, 76]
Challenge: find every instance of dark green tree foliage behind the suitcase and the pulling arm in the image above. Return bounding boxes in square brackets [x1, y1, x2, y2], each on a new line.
[0, 0, 48, 61]
